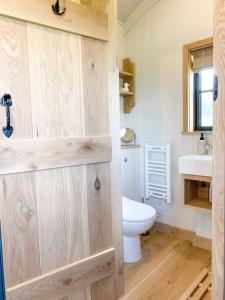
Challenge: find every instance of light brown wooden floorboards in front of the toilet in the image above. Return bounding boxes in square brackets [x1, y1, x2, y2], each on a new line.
[121, 231, 211, 300]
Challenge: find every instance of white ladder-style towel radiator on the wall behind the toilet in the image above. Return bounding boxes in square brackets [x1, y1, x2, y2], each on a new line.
[145, 143, 171, 203]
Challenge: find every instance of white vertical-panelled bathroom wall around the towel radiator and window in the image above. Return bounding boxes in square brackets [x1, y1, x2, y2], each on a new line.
[118, 0, 213, 237]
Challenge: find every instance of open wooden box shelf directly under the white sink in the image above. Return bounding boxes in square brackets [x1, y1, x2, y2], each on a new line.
[184, 175, 212, 212]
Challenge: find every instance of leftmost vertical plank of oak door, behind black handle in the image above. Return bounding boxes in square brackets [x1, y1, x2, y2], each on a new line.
[0, 17, 40, 288]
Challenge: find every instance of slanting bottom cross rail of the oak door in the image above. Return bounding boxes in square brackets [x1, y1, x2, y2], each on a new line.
[7, 248, 115, 300]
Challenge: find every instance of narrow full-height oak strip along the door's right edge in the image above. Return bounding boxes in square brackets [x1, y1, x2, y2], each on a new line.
[107, 0, 124, 298]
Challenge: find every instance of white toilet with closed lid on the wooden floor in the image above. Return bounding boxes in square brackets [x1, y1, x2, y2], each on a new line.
[123, 197, 156, 263]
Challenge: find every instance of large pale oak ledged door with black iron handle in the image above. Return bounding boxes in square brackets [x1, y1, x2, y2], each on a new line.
[0, 0, 120, 300]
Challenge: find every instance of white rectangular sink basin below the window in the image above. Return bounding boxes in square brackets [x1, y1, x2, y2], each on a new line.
[179, 155, 212, 177]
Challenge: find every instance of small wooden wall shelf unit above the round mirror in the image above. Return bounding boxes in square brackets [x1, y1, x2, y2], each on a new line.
[119, 58, 135, 113]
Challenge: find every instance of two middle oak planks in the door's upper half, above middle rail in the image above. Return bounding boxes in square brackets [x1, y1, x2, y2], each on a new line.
[28, 24, 84, 138]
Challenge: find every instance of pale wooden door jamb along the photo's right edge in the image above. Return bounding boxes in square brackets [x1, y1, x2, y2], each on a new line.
[212, 0, 225, 300]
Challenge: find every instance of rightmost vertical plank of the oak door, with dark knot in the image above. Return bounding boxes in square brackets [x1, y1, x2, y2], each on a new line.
[82, 32, 115, 300]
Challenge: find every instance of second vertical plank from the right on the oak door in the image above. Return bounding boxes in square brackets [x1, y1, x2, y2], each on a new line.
[57, 24, 91, 300]
